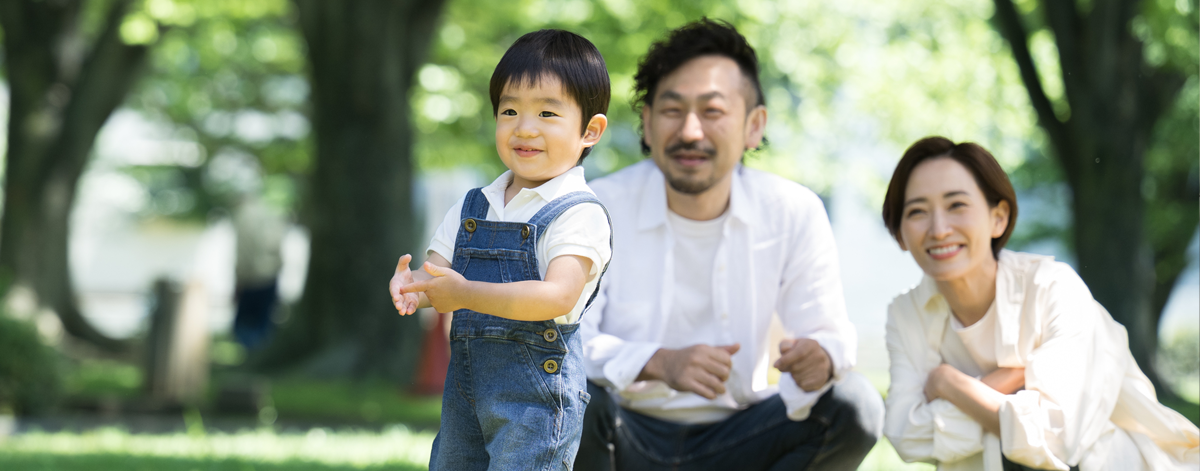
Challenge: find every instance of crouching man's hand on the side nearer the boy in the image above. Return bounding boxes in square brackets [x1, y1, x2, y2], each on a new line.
[637, 344, 742, 399]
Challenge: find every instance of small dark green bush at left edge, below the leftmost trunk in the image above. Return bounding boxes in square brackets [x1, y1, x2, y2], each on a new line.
[0, 312, 62, 415]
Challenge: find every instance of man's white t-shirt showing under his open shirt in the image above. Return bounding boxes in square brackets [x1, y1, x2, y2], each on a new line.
[635, 210, 738, 423]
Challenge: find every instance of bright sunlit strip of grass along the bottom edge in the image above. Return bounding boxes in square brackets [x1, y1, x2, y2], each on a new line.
[0, 427, 934, 471]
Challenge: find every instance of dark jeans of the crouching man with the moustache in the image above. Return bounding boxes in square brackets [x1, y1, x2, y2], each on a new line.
[575, 372, 883, 471]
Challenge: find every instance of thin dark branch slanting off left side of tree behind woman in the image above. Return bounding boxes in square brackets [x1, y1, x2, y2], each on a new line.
[995, 0, 1075, 169]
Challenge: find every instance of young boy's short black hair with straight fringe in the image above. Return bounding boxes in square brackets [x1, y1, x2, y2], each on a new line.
[488, 29, 612, 161]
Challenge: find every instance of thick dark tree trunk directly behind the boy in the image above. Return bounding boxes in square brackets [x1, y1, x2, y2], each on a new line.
[260, 0, 443, 383]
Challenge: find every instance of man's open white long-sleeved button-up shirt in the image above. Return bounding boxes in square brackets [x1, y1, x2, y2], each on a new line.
[581, 160, 857, 423]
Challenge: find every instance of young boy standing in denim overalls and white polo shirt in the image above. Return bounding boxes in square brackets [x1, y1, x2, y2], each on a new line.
[389, 30, 612, 470]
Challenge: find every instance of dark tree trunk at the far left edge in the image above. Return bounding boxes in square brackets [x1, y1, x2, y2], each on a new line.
[0, 0, 146, 351]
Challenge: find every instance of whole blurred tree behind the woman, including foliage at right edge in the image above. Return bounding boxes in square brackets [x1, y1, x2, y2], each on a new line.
[995, 0, 1200, 400]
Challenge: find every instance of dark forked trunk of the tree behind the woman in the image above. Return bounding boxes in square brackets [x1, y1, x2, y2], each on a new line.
[995, 0, 1194, 397]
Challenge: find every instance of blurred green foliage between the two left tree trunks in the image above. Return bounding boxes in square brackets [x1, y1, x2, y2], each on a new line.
[124, 0, 311, 219]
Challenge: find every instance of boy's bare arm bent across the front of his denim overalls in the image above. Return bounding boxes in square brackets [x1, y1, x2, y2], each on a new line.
[401, 254, 592, 321]
